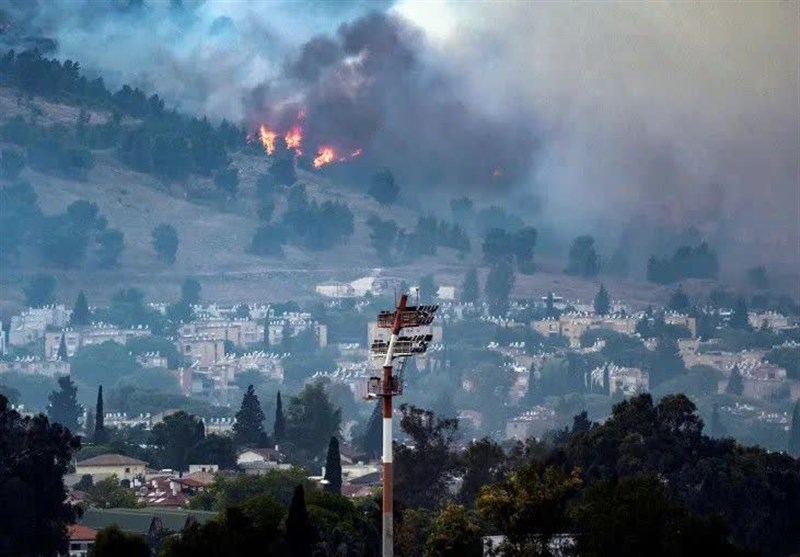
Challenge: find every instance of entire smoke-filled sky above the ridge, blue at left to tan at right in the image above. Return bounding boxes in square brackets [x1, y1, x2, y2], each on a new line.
[4, 1, 800, 272]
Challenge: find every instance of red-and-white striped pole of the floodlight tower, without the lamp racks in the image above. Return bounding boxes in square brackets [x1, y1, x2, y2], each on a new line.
[382, 294, 408, 557]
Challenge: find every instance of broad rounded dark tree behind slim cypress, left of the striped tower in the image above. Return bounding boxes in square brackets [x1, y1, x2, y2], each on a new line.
[286, 382, 342, 459]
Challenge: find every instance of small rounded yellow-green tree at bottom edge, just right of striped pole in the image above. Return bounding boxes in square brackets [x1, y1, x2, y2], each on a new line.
[423, 505, 483, 557]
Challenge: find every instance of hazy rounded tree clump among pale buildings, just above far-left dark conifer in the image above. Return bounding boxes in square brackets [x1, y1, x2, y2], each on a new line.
[70, 340, 139, 389]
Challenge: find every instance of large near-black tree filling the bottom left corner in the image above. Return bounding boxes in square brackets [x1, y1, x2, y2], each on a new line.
[0, 395, 80, 556]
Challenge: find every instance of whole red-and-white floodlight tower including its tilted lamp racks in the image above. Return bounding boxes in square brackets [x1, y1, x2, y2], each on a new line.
[367, 294, 439, 557]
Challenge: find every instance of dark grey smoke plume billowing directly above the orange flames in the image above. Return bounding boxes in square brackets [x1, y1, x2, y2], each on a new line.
[248, 13, 536, 191]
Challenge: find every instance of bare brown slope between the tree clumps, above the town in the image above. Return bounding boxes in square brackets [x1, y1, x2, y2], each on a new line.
[0, 88, 756, 308]
